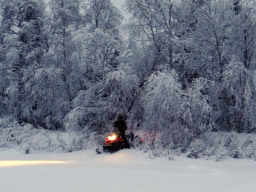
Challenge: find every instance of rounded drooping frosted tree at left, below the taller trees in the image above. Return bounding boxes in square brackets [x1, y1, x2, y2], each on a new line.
[23, 66, 70, 130]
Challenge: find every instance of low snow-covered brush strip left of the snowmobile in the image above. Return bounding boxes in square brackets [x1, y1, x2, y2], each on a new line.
[0, 117, 97, 153]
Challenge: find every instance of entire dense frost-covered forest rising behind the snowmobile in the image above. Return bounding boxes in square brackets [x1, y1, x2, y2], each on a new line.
[0, 0, 256, 150]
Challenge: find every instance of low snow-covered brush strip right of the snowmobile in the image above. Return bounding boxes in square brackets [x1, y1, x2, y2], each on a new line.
[129, 131, 256, 161]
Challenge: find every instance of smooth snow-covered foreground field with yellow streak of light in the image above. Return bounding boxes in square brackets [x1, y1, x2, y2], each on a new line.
[0, 150, 256, 192]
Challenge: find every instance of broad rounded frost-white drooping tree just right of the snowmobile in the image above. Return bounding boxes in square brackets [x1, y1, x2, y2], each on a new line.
[143, 71, 212, 145]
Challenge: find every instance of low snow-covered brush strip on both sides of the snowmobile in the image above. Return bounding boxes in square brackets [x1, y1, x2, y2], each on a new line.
[0, 117, 256, 161]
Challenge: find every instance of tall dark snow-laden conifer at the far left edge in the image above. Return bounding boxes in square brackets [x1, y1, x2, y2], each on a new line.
[2, 0, 47, 123]
